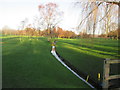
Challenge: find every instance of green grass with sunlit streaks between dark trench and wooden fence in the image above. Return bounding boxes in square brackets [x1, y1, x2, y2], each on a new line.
[57, 38, 120, 82]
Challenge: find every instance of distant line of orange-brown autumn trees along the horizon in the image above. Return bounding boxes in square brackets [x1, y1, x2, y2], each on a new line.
[2, 27, 120, 39]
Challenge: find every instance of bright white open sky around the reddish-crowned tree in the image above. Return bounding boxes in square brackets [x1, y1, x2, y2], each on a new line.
[0, 0, 80, 33]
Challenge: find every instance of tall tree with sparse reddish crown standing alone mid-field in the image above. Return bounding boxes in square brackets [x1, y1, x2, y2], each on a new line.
[39, 3, 62, 36]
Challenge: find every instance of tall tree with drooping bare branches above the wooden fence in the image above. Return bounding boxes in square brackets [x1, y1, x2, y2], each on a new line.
[77, 0, 120, 37]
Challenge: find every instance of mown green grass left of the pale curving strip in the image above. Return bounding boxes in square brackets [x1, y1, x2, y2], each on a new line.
[2, 36, 90, 88]
